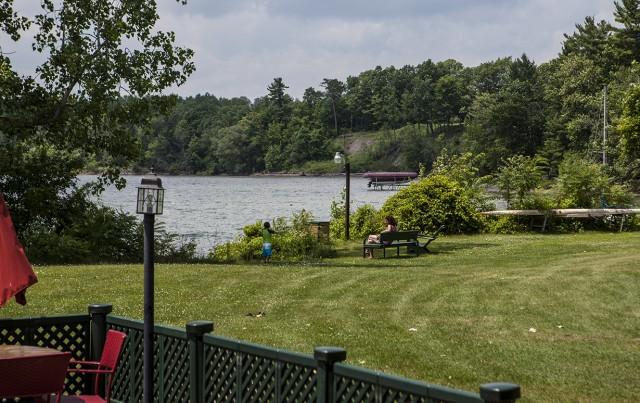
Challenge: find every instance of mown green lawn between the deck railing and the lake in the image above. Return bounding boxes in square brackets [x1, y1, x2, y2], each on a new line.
[1, 233, 640, 402]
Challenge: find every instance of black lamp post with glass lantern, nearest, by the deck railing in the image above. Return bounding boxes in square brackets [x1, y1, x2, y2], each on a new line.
[136, 168, 164, 403]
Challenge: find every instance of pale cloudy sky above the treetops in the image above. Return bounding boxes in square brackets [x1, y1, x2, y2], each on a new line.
[0, 0, 613, 99]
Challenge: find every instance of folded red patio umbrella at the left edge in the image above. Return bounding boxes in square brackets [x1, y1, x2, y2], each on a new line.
[0, 193, 38, 307]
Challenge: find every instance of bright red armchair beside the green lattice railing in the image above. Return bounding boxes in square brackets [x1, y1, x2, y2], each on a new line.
[62, 330, 127, 403]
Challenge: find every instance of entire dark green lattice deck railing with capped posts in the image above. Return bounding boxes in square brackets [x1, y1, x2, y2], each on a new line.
[0, 305, 520, 403]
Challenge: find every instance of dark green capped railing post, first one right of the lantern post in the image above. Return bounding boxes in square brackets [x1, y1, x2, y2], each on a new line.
[186, 320, 213, 403]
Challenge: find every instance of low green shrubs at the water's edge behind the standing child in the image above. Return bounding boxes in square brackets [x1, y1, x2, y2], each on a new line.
[209, 210, 336, 263]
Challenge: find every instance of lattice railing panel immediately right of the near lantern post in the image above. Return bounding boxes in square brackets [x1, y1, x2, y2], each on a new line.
[154, 334, 190, 403]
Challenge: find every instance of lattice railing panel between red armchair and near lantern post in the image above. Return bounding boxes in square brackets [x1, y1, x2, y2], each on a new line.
[109, 325, 143, 403]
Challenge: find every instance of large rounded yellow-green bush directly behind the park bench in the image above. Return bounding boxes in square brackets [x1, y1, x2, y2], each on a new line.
[381, 175, 483, 233]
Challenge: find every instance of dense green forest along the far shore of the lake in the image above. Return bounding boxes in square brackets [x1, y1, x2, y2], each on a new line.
[135, 0, 640, 184]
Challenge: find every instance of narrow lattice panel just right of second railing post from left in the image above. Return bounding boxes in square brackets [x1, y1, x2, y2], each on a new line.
[204, 344, 238, 403]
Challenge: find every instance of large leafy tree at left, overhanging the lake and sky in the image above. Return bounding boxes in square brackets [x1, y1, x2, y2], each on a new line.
[0, 0, 194, 248]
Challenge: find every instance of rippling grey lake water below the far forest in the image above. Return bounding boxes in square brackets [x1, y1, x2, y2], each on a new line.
[84, 176, 395, 253]
